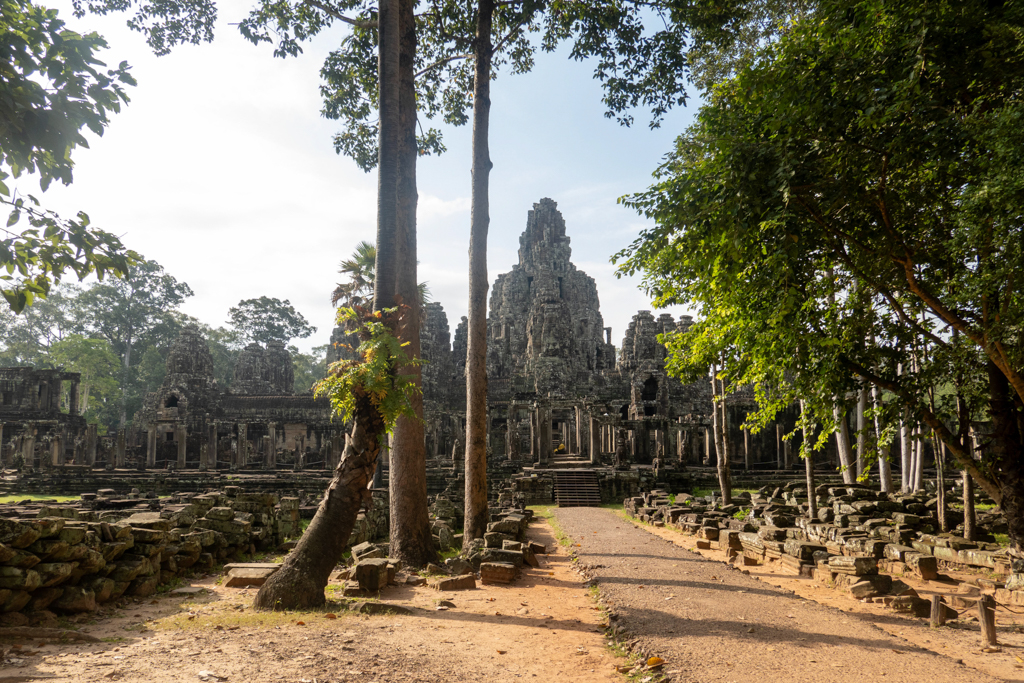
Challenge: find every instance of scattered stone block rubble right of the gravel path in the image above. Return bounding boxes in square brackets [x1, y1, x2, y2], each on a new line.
[624, 482, 1024, 617]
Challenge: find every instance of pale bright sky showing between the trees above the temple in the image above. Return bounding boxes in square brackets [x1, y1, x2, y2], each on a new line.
[28, 0, 696, 350]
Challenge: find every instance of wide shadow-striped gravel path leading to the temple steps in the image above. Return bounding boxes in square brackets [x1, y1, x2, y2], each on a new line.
[556, 508, 998, 683]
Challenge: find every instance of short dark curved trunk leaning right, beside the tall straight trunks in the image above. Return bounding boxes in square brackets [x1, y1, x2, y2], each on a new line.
[253, 393, 384, 610]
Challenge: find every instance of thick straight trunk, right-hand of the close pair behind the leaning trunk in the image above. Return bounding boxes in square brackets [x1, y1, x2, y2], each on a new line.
[388, 0, 437, 567]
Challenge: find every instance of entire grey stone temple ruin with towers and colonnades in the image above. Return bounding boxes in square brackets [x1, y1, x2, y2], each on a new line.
[0, 199, 791, 500]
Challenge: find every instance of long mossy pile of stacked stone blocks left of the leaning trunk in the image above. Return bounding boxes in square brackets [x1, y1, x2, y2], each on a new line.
[0, 486, 377, 625]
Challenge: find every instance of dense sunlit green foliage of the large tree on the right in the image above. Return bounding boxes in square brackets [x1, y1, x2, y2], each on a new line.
[617, 0, 1024, 485]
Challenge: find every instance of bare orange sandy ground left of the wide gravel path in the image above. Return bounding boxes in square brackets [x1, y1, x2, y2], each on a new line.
[0, 521, 622, 683]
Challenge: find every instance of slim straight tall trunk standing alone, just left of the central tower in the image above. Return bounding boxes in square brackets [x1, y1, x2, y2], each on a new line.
[463, 0, 495, 544]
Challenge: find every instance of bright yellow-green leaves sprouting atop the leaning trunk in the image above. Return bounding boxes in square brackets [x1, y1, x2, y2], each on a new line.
[313, 307, 422, 433]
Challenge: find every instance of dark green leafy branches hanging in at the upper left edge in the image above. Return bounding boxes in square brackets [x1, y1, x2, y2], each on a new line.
[0, 0, 138, 312]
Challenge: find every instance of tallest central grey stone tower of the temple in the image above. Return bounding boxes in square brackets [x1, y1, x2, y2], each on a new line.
[487, 199, 615, 395]
